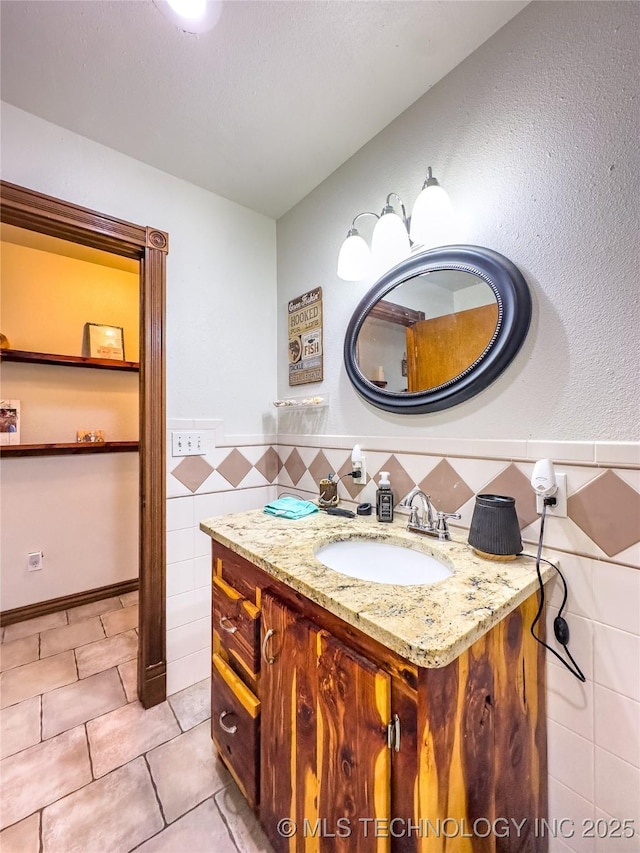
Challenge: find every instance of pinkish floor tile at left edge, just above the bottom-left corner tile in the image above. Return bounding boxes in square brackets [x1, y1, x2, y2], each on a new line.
[0, 726, 91, 828]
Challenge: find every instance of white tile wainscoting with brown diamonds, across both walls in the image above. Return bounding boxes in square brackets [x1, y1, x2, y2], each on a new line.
[167, 427, 640, 853]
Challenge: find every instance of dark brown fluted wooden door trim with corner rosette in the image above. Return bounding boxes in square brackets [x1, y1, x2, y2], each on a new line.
[0, 181, 169, 708]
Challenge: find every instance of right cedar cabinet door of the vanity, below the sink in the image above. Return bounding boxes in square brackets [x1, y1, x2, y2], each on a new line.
[317, 631, 391, 853]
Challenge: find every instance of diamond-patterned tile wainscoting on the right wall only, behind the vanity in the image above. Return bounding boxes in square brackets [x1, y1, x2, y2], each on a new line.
[277, 435, 640, 853]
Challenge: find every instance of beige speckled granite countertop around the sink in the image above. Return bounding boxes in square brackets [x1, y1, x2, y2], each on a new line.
[200, 510, 553, 667]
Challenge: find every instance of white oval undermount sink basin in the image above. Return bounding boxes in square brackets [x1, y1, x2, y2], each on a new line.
[316, 539, 453, 586]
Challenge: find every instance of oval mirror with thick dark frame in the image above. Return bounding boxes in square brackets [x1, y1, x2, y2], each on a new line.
[344, 246, 531, 414]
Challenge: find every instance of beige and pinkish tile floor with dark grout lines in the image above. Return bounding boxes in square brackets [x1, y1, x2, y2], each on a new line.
[0, 593, 272, 853]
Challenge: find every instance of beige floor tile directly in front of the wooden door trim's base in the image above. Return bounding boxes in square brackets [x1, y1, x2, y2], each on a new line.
[87, 702, 180, 778]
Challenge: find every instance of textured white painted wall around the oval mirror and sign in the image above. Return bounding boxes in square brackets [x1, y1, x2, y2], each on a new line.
[277, 2, 640, 440]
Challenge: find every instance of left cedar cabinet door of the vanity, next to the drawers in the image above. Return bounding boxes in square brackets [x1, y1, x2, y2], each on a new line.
[260, 595, 319, 853]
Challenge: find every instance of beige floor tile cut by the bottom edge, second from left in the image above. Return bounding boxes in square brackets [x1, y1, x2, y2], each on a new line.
[42, 758, 164, 853]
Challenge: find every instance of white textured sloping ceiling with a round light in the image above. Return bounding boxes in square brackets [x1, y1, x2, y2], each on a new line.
[0, 0, 526, 219]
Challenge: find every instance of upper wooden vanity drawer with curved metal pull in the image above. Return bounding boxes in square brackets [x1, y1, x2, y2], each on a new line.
[213, 576, 260, 675]
